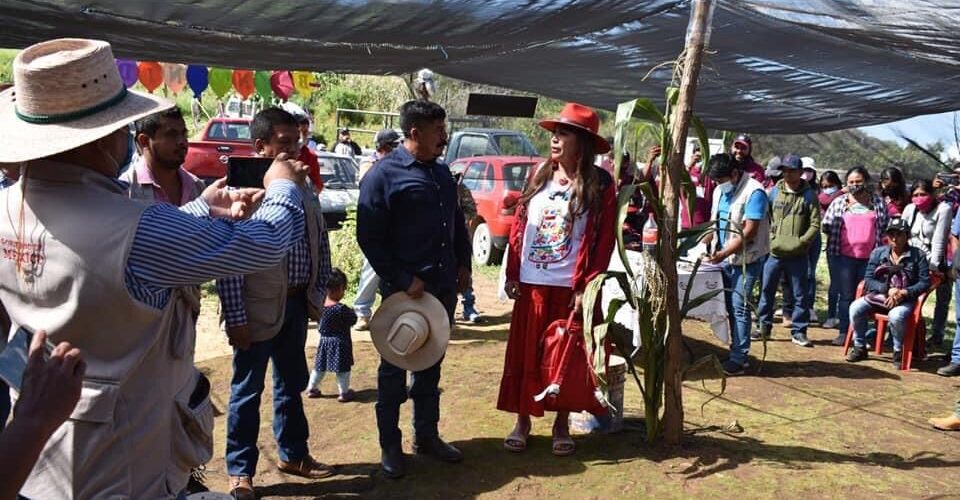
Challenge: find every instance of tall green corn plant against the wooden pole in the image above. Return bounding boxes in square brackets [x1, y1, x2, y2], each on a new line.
[583, 87, 750, 442]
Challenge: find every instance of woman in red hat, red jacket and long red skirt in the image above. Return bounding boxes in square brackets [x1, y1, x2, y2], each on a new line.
[497, 103, 617, 456]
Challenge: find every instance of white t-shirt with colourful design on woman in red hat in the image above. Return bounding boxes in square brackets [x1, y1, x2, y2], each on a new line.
[520, 181, 587, 287]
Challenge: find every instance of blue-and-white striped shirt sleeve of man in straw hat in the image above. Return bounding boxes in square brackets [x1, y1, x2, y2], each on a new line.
[125, 180, 304, 309]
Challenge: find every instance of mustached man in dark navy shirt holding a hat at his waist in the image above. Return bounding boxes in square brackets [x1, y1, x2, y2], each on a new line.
[357, 101, 471, 478]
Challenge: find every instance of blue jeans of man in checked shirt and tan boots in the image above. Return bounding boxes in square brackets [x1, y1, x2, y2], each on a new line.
[227, 293, 310, 477]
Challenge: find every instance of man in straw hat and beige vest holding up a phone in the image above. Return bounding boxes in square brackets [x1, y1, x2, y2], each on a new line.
[0, 39, 305, 499]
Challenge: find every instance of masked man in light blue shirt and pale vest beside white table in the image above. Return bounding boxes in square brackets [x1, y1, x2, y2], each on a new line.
[706, 153, 770, 375]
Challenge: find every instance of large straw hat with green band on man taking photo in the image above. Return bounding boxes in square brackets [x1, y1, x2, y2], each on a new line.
[0, 38, 173, 163]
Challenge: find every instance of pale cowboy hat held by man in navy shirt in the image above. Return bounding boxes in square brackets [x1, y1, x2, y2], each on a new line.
[370, 292, 450, 372]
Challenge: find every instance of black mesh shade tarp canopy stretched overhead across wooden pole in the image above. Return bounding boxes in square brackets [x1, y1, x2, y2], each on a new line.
[0, 0, 960, 133]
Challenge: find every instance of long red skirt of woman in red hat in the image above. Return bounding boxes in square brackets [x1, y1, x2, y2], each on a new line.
[497, 283, 573, 417]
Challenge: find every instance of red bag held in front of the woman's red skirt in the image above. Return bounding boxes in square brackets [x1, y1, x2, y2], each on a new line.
[533, 312, 607, 416]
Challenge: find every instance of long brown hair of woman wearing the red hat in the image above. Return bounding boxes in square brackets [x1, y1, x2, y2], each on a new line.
[520, 125, 601, 216]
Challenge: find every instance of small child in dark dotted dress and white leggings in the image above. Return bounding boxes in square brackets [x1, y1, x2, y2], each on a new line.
[307, 268, 357, 403]
